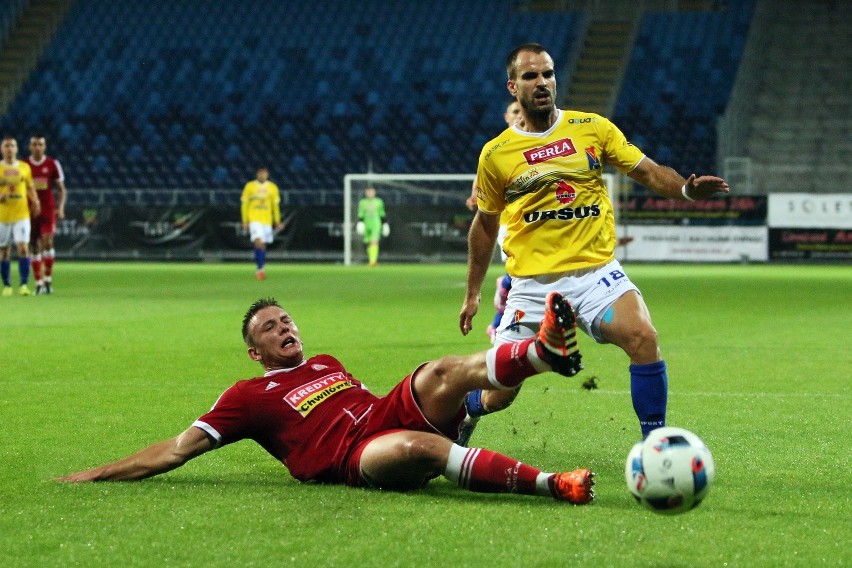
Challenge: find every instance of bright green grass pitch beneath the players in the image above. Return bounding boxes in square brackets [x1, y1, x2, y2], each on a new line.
[0, 262, 852, 567]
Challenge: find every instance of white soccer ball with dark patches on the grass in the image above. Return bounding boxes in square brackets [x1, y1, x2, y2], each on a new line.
[624, 427, 716, 515]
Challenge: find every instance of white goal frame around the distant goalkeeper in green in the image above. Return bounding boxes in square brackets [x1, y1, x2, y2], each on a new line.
[342, 173, 623, 266]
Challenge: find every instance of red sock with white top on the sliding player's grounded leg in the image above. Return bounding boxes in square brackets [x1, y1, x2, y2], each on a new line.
[444, 444, 542, 495]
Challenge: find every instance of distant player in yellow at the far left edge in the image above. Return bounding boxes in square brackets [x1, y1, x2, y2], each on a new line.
[0, 136, 41, 296]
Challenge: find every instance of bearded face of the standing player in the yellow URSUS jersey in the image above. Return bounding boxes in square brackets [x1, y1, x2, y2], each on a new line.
[506, 51, 556, 120]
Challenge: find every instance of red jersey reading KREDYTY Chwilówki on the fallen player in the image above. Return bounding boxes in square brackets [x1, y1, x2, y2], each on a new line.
[193, 355, 379, 482]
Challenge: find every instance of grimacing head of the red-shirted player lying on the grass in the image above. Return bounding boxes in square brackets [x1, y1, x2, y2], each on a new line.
[248, 306, 304, 370]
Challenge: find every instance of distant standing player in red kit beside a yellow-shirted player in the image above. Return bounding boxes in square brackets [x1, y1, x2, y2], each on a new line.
[24, 134, 66, 294]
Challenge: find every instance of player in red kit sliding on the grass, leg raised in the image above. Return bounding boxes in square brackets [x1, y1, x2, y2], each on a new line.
[58, 293, 594, 505]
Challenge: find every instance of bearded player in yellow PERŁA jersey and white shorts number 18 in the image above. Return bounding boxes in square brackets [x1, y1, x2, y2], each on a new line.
[459, 44, 729, 436]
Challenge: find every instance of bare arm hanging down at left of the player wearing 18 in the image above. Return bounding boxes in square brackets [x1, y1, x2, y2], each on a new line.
[459, 210, 500, 335]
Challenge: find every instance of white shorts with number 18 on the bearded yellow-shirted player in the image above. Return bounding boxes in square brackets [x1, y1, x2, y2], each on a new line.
[495, 260, 639, 344]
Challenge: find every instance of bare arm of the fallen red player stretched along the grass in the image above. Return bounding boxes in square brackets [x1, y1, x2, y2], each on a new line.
[56, 426, 214, 483]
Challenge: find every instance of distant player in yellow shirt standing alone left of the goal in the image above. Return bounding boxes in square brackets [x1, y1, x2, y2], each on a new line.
[240, 167, 284, 280]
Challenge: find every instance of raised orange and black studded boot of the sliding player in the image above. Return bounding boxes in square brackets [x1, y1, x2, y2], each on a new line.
[536, 292, 583, 377]
